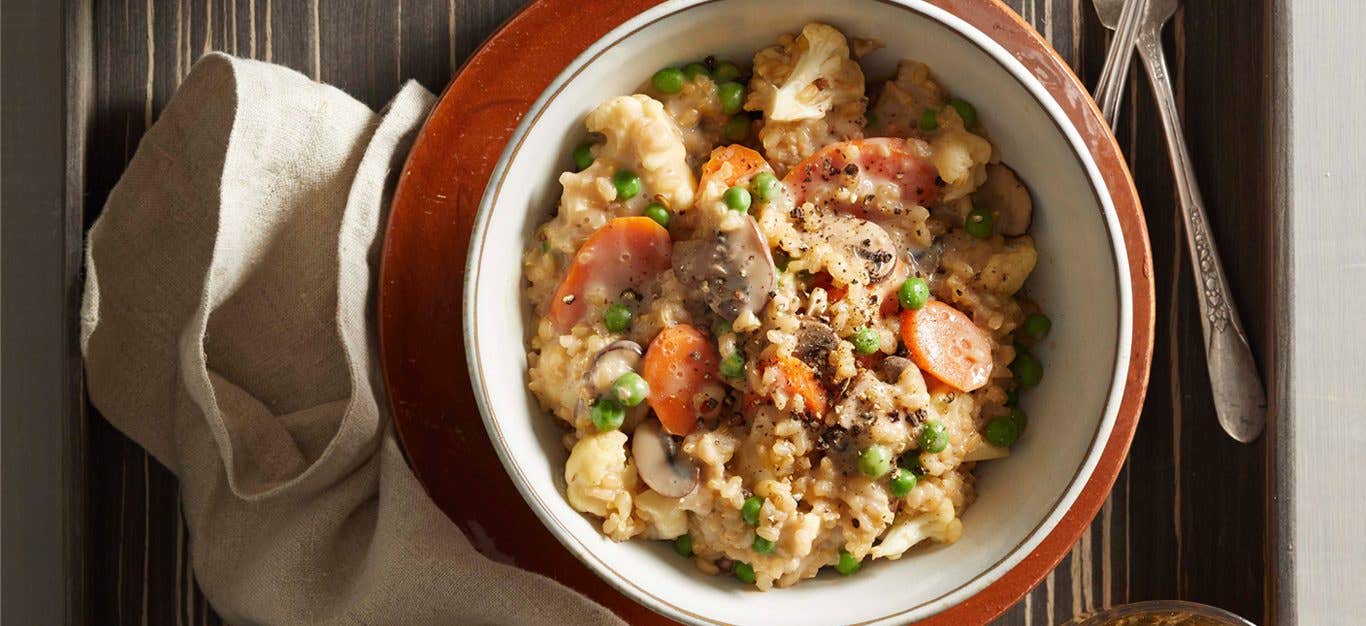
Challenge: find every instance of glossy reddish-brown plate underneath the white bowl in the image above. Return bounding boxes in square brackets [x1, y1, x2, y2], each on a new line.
[378, 0, 1154, 625]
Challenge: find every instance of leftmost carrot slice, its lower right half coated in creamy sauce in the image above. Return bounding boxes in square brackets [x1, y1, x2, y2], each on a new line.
[549, 216, 673, 334]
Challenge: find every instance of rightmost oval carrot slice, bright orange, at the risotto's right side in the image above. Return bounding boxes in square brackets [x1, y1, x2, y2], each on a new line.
[902, 301, 992, 391]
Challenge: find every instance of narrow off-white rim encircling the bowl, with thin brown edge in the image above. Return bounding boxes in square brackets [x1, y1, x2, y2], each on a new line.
[462, 0, 1135, 623]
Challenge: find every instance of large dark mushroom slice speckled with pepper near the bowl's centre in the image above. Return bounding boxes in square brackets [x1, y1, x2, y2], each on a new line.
[673, 216, 777, 321]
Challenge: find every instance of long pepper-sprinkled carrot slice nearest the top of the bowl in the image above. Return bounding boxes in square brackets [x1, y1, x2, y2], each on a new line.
[783, 137, 940, 219]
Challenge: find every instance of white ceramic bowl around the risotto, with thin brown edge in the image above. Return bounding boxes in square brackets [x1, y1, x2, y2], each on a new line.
[464, 0, 1131, 625]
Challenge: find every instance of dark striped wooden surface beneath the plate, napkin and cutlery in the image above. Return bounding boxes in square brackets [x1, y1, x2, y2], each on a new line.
[67, 0, 1274, 625]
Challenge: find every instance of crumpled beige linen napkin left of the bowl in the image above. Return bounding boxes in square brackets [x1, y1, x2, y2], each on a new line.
[81, 53, 620, 625]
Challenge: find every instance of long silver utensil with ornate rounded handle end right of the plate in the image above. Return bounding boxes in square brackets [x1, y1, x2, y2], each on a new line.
[1094, 0, 1266, 443]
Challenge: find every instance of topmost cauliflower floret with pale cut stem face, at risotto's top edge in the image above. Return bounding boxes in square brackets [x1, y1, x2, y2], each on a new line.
[744, 23, 867, 175]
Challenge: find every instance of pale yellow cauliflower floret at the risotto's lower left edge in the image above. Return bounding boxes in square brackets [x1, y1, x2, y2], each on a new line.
[564, 431, 645, 541]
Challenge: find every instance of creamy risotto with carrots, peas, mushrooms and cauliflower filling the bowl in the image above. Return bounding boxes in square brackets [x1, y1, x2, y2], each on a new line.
[525, 23, 1049, 589]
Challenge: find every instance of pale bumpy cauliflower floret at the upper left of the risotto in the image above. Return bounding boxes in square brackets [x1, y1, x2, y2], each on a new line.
[587, 94, 697, 213]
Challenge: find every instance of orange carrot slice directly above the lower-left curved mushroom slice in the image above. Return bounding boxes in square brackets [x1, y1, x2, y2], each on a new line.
[641, 324, 720, 435]
